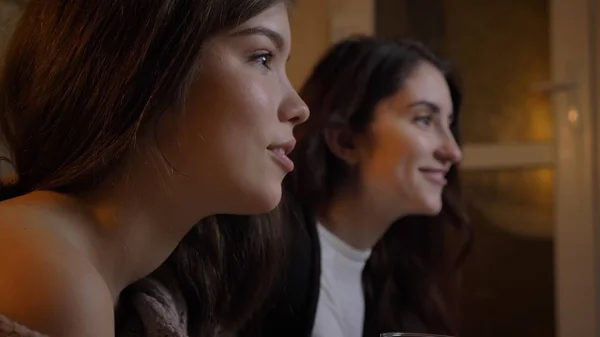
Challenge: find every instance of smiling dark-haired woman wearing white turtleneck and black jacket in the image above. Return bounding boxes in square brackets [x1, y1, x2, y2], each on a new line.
[243, 37, 469, 337]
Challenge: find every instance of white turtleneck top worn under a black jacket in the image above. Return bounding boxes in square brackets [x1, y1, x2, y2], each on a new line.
[312, 223, 371, 337]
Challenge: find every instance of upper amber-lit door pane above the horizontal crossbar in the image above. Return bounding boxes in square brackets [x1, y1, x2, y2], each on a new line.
[376, 0, 554, 143]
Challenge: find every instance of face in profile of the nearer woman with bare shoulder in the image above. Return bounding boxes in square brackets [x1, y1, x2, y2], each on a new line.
[152, 2, 308, 214]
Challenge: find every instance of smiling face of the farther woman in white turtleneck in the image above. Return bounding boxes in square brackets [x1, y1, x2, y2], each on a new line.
[358, 62, 462, 216]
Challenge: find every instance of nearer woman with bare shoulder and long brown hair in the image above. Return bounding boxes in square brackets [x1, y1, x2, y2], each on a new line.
[0, 0, 308, 337]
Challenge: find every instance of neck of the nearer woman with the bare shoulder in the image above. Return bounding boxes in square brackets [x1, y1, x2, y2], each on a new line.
[79, 159, 210, 300]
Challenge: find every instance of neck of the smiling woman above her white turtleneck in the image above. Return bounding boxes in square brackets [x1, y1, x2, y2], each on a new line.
[319, 186, 402, 250]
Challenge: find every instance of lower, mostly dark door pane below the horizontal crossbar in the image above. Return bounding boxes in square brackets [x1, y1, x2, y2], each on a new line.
[462, 169, 555, 337]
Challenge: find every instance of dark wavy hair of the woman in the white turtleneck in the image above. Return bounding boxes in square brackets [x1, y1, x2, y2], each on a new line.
[286, 36, 470, 336]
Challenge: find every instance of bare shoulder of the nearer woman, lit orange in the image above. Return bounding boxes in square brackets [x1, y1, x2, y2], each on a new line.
[0, 200, 114, 337]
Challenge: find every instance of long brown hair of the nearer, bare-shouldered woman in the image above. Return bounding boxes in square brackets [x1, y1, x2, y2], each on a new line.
[0, 0, 289, 334]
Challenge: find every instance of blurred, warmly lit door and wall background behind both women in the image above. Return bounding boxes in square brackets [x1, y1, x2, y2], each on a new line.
[0, 0, 600, 337]
